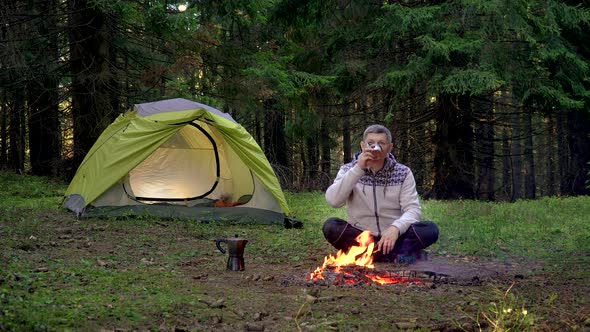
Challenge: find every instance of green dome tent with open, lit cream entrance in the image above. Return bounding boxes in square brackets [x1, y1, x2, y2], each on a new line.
[63, 99, 290, 224]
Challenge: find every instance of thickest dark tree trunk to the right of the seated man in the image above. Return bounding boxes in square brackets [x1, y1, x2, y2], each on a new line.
[431, 95, 475, 199]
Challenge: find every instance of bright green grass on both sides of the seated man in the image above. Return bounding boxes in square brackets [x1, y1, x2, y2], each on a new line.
[287, 192, 590, 260]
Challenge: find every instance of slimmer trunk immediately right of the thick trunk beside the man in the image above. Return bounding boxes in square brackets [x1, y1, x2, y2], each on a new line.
[475, 94, 496, 201]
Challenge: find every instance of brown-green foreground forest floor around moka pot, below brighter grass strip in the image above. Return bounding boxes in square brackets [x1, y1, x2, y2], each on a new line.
[0, 209, 590, 331]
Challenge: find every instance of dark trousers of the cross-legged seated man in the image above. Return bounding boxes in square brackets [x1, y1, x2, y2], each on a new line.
[323, 218, 438, 261]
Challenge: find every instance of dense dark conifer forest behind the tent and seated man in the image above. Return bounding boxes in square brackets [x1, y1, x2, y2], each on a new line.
[0, 0, 590, 200]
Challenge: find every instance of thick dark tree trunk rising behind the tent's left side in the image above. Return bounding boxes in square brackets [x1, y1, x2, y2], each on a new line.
[69, 0, 116, 164]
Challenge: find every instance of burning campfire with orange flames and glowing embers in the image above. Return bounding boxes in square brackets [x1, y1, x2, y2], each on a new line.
[307, 231, 420, 285]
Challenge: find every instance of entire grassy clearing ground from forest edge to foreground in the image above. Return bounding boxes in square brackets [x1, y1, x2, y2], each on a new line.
[0, 172, 590, 331]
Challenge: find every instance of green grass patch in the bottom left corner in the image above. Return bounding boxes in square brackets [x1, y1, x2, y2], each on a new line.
[0, 260, 197, 329]
